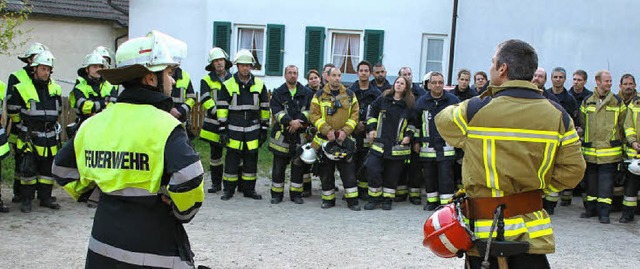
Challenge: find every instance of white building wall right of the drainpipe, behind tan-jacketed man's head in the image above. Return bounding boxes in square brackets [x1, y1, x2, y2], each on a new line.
[454, 0, 640, 92]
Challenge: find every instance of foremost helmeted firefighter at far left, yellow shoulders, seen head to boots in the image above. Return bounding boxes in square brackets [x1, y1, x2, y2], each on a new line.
[7, 51, 62, 213]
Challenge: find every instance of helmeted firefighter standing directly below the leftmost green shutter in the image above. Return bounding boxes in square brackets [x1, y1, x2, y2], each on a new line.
[200, 47, 232, 193]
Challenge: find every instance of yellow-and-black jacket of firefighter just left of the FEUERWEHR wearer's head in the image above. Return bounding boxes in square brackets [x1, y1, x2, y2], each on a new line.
[69, 77, 117, 116]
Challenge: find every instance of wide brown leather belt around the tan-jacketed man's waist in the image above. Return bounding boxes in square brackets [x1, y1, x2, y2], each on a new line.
[462, 190, 542, 220]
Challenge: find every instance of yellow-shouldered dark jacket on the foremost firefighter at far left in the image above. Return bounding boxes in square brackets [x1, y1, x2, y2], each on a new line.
[11, 79, 62, 157]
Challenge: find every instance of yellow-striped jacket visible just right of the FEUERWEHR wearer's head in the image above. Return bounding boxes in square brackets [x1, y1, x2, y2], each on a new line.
[171, 67, 196, 122]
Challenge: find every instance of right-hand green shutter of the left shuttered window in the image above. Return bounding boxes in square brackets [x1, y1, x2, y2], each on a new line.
[264, 24, 284, 76]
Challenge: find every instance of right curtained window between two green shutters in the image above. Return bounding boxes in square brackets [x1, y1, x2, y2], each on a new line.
[329, 32, 362, 74]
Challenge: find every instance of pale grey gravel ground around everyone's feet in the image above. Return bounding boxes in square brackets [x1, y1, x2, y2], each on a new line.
[0, 175, 640, 268]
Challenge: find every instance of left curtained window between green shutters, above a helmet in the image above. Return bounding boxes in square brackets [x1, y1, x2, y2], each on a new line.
[236, 26, 265, 71]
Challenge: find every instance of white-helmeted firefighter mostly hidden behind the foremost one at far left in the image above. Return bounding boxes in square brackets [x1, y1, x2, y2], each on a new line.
[3, 42, 48, 203]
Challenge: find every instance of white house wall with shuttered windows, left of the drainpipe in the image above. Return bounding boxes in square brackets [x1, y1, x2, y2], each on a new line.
[129, 0, 453, 90]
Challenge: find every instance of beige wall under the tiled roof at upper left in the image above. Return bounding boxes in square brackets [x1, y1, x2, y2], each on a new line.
[0, 16, 126, 95]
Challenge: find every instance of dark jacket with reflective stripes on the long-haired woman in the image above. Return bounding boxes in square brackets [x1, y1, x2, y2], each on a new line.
[366, 94, 417, 160]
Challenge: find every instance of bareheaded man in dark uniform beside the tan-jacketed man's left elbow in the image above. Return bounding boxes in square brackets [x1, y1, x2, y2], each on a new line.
[414, 71, 460, 211]
